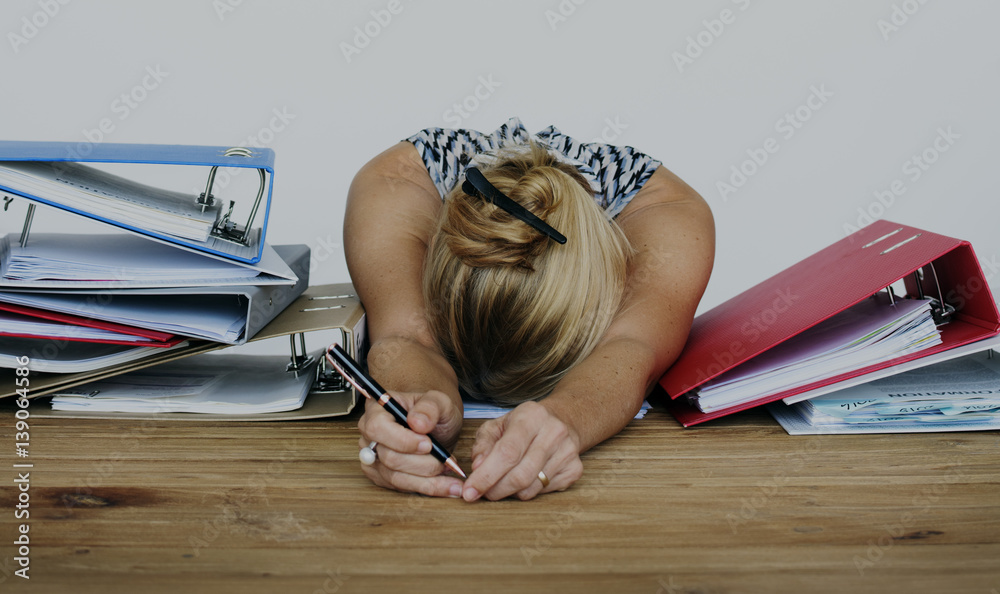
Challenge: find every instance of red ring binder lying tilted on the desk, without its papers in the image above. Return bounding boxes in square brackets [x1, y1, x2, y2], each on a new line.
[659, 220, 1000, 427]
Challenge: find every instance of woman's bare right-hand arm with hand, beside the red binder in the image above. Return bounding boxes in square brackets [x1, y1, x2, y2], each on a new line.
[463, 166, 715, 501]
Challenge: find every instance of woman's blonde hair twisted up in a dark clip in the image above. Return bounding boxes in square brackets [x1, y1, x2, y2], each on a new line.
[423, 143, 632, 405]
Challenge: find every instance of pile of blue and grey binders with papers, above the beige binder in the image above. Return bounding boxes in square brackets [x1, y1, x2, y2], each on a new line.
[0, 141, 309, 373]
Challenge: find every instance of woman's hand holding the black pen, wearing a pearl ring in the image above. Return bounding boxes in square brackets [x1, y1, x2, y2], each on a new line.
[358, 390, 463, 497]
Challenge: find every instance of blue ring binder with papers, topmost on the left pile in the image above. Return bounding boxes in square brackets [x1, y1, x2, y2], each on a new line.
[0, 141, 274, 264]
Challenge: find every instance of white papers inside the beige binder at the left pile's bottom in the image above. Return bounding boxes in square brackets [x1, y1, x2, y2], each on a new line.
[52, 354, 319, 415]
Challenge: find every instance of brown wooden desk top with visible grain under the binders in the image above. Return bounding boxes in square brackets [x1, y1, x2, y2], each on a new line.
[0, 402, 1000, 594]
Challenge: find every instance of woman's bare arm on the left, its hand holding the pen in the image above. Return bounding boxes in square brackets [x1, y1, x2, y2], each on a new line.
[344, 142, 462, 496]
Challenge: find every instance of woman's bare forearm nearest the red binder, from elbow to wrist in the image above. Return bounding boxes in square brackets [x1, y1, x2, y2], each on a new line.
[542, 338, 664, 453]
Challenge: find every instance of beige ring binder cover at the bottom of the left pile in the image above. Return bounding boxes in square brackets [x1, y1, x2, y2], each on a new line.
[0, 284, 367, 421]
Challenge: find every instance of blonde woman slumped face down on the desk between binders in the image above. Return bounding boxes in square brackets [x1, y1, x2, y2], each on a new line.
[344, 118, 714, 501]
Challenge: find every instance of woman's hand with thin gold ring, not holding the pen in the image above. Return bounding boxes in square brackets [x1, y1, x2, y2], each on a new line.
[462, 402, 583, 501]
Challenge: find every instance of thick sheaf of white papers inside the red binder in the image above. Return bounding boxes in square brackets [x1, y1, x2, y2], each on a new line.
[691, 293, 941, 412]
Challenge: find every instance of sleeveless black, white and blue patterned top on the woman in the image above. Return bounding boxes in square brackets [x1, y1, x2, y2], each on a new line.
[406, 118, 660, 218]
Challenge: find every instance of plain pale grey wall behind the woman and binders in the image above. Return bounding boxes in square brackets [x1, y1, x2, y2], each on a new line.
[0, 0, 1000, 328]
